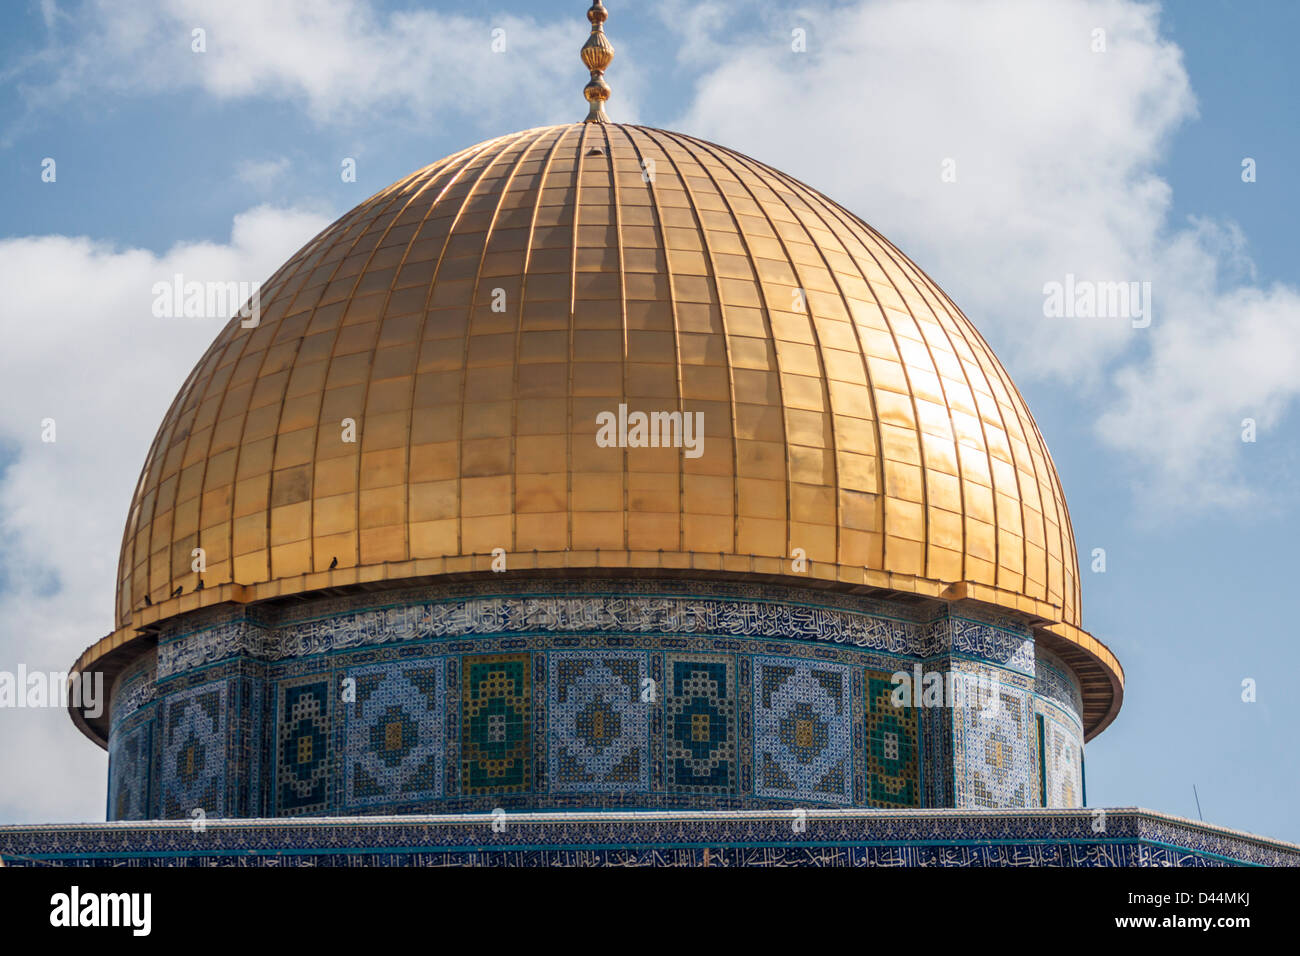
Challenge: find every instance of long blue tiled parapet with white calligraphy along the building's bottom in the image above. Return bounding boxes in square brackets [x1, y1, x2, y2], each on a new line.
[0, 809, 1300, 866]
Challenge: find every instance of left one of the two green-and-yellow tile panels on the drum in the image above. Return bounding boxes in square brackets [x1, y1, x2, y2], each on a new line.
[460, 654, 533, 793]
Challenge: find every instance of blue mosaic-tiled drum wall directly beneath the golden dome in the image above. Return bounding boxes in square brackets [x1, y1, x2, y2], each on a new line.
[108, 583, 1079, 819]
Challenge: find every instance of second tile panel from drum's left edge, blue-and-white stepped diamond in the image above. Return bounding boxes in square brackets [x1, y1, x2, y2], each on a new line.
[160, 682, 228, 819]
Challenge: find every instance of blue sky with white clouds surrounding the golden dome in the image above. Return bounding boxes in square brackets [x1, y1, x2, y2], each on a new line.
[0, 0, 1300, 842]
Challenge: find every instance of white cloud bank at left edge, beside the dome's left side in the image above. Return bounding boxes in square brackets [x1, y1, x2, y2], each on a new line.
[0, 207, 329, 821]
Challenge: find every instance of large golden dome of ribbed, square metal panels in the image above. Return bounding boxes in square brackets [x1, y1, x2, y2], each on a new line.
[83, 124, 1122, 732]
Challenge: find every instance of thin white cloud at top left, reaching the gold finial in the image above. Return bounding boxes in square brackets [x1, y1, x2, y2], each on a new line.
[20, 0, 637, 134]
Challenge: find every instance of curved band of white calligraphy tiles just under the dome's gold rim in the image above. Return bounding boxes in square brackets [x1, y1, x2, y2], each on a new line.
[144, 579, 1034, 680]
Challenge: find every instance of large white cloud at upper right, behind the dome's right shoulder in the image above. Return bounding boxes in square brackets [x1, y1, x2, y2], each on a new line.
[664, 0, 1300, 506]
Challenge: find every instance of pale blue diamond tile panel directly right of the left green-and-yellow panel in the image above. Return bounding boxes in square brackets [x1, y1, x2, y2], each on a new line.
[547, 650, 650, 793]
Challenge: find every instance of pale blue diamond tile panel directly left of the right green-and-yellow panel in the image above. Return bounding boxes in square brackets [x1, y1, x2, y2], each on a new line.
[754, 657, 853, 804]
